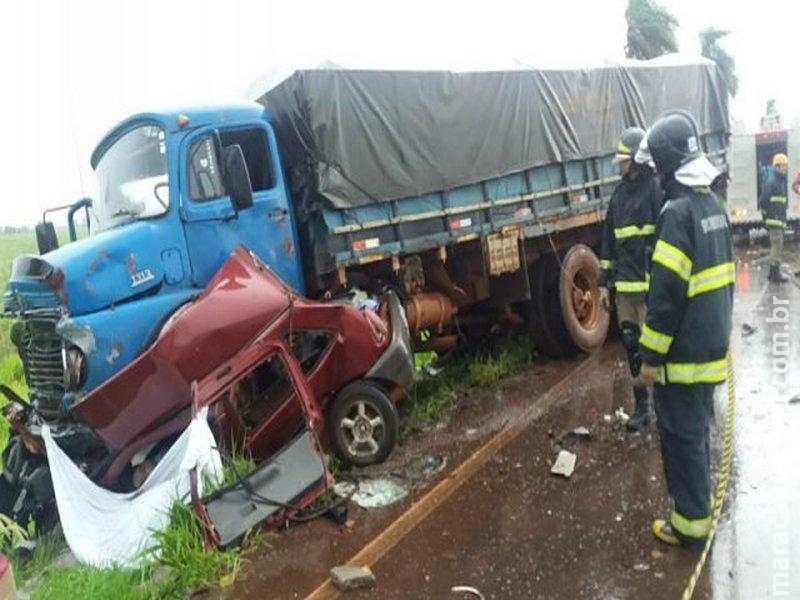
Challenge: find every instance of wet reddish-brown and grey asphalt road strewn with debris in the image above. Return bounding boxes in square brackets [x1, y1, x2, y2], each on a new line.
[214, 241, 800, 600]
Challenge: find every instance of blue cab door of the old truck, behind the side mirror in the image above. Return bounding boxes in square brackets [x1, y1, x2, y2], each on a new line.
[181, 124, 304, 293]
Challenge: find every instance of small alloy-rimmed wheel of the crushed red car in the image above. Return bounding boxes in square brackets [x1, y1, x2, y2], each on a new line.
[328, 381, 400, 467]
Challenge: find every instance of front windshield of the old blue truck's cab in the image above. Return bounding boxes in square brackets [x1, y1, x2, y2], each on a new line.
[91, 124, 169, 233]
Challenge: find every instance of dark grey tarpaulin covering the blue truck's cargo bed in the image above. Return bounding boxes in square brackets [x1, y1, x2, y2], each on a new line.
[258, 58, 729, 211]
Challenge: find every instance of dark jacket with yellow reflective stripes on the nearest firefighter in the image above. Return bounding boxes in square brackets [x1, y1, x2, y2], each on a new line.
[639, 180, 735, 384]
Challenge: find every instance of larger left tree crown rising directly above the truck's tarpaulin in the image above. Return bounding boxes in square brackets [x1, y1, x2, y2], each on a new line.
[625, 0, 678, 60]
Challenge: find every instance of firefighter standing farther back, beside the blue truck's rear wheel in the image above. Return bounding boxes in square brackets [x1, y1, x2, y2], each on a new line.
[600, 127, 662, 431]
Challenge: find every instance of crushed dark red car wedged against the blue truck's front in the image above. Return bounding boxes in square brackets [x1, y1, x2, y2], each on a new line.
[0, 247, 413, 543]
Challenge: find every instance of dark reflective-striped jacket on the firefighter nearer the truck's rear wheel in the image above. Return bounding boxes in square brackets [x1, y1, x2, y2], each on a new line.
[600, 166, 662, 294]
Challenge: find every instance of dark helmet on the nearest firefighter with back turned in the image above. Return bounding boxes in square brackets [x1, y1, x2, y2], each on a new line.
[647, 111, 703, 179]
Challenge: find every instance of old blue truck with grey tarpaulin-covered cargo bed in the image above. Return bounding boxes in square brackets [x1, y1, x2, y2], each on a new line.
[4, 60, 729, 524]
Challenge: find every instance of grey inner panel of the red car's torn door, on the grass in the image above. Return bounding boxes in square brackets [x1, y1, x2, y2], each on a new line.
[202, 429, 327, 548]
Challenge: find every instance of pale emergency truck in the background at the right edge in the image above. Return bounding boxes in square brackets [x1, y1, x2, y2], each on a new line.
[728, 123, 800, 232]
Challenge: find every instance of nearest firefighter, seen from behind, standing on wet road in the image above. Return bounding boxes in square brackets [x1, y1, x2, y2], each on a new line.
[639, 112, 735, 545]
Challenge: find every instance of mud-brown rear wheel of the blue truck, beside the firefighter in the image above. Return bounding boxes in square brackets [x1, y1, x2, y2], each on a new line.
[559, 244, 610, 352]
